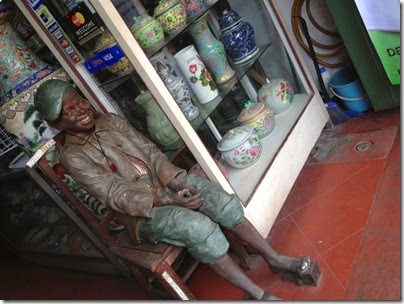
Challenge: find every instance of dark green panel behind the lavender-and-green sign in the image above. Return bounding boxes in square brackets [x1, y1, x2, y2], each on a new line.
[325, 0, 400, 111]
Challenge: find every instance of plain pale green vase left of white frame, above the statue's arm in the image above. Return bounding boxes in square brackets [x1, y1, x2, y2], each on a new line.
[135, 91, 184, 150]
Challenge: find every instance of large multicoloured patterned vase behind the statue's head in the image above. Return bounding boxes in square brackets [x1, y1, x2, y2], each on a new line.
[0, 5, 67, 154]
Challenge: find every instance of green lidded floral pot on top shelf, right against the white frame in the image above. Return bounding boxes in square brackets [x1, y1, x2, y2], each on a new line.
[130, 14, 164, 55]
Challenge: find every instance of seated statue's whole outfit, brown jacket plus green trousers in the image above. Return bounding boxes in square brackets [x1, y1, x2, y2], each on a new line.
[59, 113, 244, 262]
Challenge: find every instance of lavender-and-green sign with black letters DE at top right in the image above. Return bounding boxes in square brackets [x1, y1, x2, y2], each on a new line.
[355, 0, 401, 85]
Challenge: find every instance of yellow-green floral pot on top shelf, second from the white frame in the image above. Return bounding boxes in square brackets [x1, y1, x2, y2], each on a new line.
[154, 0, 187, 35]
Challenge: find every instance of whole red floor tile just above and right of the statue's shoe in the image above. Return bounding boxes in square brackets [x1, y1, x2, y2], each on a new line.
[290, 180, 374, 253]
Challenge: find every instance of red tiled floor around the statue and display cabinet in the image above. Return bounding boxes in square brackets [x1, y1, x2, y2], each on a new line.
[0, 108, 401, 301]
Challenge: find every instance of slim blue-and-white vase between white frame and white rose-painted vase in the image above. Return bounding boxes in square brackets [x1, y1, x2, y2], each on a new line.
[157, 63, 199, 121]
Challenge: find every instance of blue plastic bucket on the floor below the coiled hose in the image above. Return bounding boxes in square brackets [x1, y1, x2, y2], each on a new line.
[328, 68, 372, 112]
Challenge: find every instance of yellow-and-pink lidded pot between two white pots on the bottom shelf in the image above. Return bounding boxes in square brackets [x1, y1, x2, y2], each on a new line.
[237, 102, 275, 138]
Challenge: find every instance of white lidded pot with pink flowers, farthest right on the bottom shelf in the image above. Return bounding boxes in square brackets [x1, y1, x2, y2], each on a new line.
[257, 78, 294, 114]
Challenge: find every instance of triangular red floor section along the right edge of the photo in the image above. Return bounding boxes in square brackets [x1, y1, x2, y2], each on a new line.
[346, 127, 401, 300]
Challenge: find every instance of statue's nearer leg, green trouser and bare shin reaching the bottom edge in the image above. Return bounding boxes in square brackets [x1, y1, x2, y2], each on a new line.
[138, 206, 277, 299]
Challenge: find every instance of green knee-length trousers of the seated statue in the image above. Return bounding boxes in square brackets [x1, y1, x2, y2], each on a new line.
[138, 174, 244, 263]
